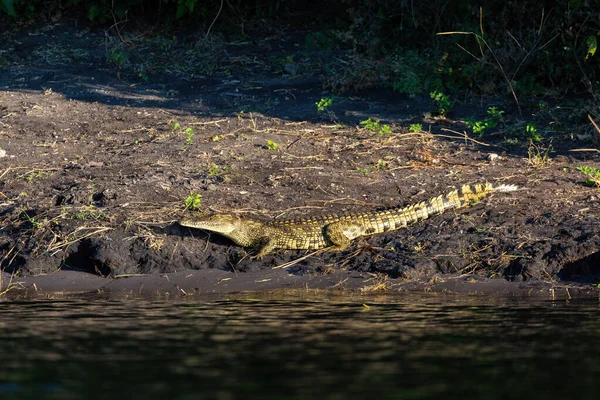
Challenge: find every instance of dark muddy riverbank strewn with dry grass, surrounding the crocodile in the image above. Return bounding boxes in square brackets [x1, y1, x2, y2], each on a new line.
[0, 23, 600, 296]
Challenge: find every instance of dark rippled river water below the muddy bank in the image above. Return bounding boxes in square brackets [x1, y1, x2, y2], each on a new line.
[0, 296, 600, 400]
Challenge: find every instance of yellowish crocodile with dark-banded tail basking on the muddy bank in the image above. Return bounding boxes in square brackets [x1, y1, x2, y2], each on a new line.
[179, 182, 518, 258]
